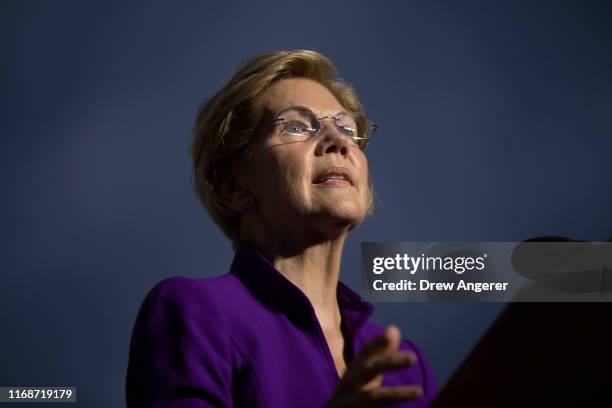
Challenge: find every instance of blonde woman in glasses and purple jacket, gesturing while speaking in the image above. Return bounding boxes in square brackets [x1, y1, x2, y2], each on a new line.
[126, 50, 436, 407]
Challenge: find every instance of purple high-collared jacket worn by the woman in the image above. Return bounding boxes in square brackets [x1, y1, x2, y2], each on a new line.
[126, 242, 437, 408]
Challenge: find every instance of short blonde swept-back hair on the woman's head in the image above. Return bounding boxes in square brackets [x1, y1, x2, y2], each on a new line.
[191, 50, 374, 247]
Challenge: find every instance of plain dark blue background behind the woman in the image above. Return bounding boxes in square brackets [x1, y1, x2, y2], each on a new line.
[0, 0, 612, 406]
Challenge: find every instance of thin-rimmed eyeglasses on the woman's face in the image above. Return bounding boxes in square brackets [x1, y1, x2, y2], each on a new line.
[273, 108, 377, 148]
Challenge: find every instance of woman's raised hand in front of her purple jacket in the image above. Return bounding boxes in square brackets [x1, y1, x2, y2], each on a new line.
[326, 325, 423, 408]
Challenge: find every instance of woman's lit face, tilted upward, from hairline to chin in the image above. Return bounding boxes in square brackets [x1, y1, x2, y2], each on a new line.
[246, 78, 369, 237]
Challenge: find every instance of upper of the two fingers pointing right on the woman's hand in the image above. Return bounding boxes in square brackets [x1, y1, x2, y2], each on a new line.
[339, 351, 417, 390]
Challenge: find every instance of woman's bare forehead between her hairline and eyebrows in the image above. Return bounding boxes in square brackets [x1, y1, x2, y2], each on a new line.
[260, 78, 344, 114]
